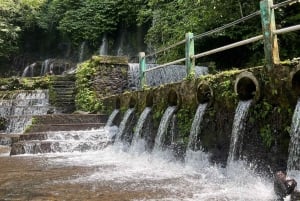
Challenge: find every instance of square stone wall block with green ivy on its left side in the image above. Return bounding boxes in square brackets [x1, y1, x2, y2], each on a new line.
[75, 56, 128, 112]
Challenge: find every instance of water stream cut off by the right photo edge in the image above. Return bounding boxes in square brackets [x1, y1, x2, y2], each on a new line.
[287, 99, 300, 171]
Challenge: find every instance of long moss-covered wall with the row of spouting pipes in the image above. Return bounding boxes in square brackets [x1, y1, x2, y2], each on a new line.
[103, 63, 299, 171]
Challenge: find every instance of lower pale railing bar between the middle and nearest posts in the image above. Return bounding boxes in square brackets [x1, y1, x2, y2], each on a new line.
[191, 35, 263, 59]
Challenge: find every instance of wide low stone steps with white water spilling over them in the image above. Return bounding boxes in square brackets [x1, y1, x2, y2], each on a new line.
[10, 114, 109, 155]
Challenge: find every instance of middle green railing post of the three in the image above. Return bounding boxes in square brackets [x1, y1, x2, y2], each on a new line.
[185, 32, 195, 78]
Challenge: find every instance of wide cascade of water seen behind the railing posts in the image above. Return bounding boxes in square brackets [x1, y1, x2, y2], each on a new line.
[128, 63, 208, 90]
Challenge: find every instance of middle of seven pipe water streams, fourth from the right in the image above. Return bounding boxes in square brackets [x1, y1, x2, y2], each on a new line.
[153, 106, 176, 151]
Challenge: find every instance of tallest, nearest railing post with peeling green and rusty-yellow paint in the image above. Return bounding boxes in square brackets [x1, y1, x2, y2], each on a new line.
[260, 0, 280, 71]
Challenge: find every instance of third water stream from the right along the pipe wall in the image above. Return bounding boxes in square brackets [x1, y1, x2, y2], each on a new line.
[187, 103, 207, 150]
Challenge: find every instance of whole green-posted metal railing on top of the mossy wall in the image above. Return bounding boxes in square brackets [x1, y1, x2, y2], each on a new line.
[139, 0, 300, 88]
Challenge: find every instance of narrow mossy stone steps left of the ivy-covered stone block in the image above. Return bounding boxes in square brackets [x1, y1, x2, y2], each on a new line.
[50, 74, 76, 113]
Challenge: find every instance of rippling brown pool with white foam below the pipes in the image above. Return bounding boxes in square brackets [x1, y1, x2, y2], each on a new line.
[0, 130, 274, 201]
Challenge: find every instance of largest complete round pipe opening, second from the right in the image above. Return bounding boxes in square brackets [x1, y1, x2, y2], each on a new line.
[234, 72, 259, 100]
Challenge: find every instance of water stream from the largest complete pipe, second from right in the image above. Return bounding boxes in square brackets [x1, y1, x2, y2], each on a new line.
[227, 100, 252, 163]
